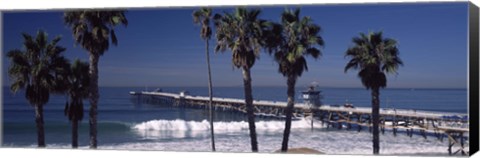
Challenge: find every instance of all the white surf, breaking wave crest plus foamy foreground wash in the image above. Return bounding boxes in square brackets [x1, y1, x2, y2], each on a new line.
[3, 119, 469, 156]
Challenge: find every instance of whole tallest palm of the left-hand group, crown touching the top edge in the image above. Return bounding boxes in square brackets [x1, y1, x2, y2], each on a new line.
[64, 10, 128, 149]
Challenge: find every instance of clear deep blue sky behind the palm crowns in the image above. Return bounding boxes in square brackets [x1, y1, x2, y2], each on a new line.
[2, 2, 468, 88]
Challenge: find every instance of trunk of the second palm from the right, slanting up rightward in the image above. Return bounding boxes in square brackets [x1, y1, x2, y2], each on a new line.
[282, 76, 296, 152]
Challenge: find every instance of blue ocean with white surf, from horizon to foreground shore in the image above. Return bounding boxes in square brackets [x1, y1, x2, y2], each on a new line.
[2, 87, 468, 155]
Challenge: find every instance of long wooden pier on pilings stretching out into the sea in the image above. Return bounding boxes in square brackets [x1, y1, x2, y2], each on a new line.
[130, 92, 469, 155]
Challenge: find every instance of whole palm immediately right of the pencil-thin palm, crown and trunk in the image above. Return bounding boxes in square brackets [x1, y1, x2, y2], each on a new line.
[214, 8, 268, 152]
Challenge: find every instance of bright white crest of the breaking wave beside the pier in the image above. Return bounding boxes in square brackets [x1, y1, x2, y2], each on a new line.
[132, 118, 323, 139]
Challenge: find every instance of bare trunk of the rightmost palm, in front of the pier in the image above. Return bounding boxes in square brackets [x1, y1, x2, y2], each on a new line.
[372, 87, 380, 155]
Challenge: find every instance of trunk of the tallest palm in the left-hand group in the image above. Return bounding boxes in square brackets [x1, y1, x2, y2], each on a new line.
[89, 53, 100, 149]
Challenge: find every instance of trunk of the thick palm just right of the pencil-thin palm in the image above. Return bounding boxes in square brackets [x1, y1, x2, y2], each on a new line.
[242, 66, 258, 152]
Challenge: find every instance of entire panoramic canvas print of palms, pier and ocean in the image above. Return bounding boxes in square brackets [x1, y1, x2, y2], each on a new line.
[2, 2, 476, 156]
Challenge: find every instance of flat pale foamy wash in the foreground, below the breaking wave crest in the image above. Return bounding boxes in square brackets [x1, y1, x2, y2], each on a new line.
[4, 126, 469, 156]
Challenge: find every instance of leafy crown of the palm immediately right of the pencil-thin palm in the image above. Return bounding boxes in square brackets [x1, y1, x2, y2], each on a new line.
[213, 7, 270, 68]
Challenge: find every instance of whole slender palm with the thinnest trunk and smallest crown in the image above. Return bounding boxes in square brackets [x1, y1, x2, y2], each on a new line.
[193, 8, 215, 151]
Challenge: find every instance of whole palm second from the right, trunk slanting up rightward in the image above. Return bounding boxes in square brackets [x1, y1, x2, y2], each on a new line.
[267, 9, 324, 152]
